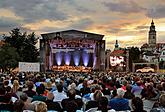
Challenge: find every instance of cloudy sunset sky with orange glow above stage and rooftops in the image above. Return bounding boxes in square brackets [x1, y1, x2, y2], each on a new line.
[0, 0, 165, 50]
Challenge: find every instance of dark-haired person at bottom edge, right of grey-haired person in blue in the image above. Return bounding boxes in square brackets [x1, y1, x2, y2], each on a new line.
[131, 97, 147, 112]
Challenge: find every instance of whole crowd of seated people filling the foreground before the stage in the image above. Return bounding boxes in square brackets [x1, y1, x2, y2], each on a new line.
[0, 72, 165, 112]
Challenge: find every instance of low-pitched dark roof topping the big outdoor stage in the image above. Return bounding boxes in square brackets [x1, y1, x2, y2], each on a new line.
[41, 30, 104, 41]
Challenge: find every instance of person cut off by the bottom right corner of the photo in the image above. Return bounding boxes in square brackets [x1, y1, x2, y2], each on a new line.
[150, 94, 165, 112]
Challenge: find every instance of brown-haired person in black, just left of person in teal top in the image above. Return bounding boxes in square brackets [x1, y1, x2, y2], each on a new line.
[24, 81, 36, 98]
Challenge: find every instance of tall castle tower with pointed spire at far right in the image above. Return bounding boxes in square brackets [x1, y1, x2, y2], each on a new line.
[148, 20, 156, 48]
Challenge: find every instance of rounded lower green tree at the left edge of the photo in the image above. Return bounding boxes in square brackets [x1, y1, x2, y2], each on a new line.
[0, 44, 21, 72]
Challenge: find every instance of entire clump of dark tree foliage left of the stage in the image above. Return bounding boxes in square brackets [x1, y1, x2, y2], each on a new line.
[0, 28, 39, 72]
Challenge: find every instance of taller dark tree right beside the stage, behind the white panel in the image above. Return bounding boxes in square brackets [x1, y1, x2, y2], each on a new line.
[4, 28, 39, 62]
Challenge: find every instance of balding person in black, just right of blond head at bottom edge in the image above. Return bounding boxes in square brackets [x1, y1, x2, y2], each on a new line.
[45, 92, 62, 112]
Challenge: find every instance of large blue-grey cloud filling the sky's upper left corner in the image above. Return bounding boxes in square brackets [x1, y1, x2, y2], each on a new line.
[1, 0, 68, 23]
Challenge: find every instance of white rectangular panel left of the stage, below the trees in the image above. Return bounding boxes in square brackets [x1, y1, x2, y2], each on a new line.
[19, 62, 40, 72]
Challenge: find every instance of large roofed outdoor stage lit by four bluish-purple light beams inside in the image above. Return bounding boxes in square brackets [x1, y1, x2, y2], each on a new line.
[40, 30, 105, 72]
